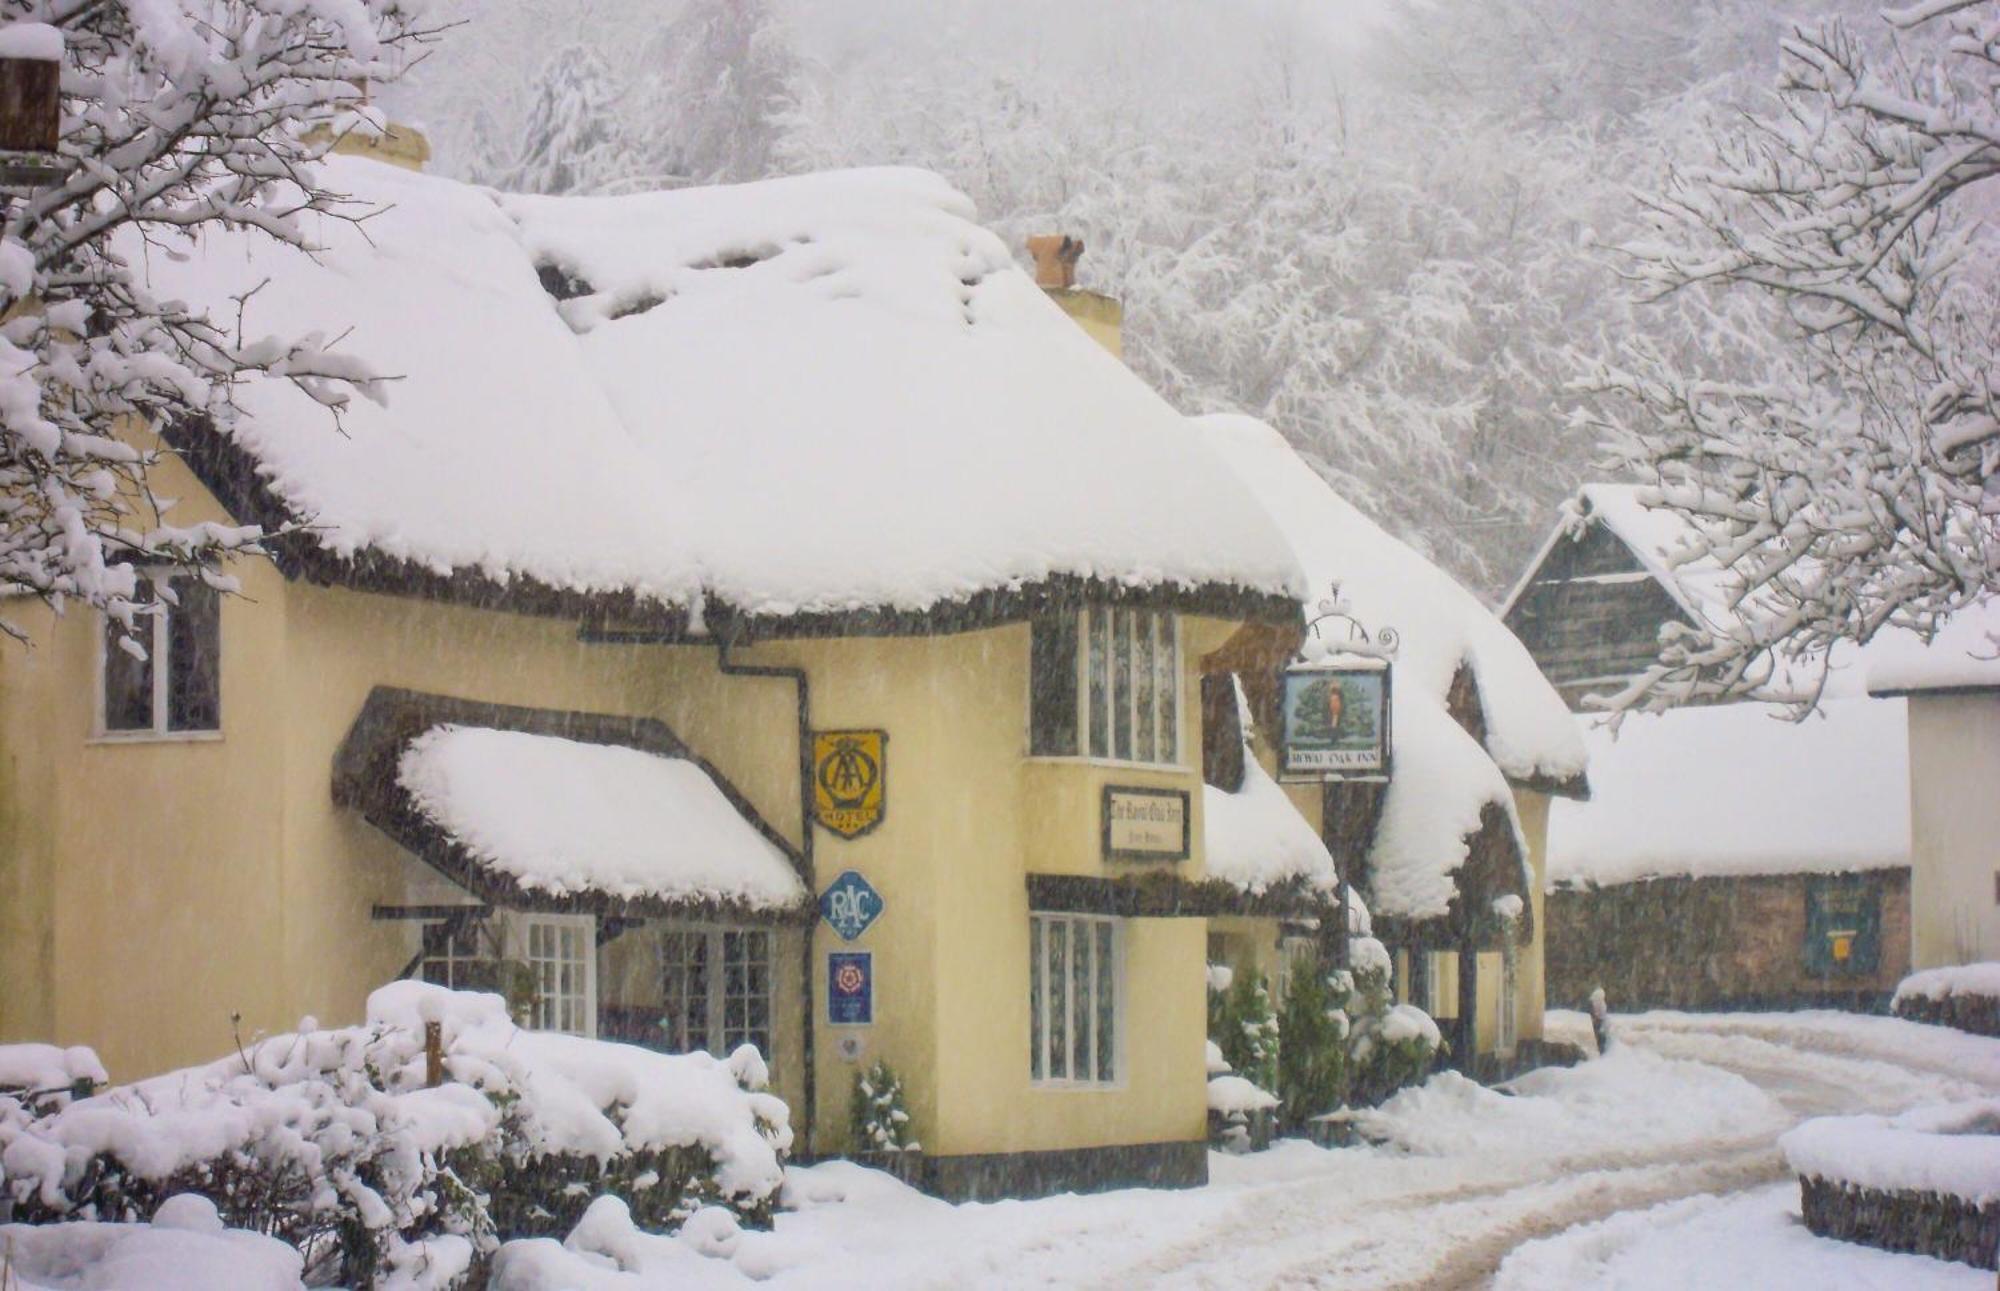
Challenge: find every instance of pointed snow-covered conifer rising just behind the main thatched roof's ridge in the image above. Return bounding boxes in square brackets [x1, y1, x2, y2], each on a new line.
[474, 44, 646, 192]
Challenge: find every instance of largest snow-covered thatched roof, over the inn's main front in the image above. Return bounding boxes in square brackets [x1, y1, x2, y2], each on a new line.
[152, 158, 1302, 631]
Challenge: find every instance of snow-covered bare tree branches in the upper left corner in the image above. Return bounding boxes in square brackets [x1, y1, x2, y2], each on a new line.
[0, 0, 426, 636]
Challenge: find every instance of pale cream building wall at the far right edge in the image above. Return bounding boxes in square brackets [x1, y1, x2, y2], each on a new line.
[1910, 691, 2000, 969]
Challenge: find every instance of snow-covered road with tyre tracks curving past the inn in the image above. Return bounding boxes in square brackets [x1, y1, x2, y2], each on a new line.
[496, 1013, 2000, 1291]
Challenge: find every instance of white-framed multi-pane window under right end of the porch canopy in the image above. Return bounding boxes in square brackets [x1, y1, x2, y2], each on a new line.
[660, 927, 772, 1061]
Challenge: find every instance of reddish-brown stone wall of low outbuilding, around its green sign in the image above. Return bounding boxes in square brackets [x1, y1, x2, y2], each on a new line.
[1546, 869, 1910, 1011]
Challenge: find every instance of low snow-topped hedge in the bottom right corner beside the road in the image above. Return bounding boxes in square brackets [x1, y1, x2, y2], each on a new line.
[1778, 1099, 2000, 1269]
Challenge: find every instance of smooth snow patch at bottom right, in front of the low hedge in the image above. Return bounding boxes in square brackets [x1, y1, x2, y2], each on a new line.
[1494, 1183, 1994, 1291]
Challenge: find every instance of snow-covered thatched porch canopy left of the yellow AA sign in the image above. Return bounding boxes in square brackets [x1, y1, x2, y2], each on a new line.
[334, 687, 810, 917]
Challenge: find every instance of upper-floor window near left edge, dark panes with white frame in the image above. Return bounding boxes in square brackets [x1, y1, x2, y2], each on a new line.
[98, 570, 222, 735]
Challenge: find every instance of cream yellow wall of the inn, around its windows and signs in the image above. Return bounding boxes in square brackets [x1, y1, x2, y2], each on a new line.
[0, 431, 1232, 1153]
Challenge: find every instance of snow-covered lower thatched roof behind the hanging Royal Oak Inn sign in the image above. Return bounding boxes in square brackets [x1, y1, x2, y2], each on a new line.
[1196, 416, 1586, 919]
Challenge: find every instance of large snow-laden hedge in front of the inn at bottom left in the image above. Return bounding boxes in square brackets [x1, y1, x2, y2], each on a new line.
[0, 981, 792, 1285]
